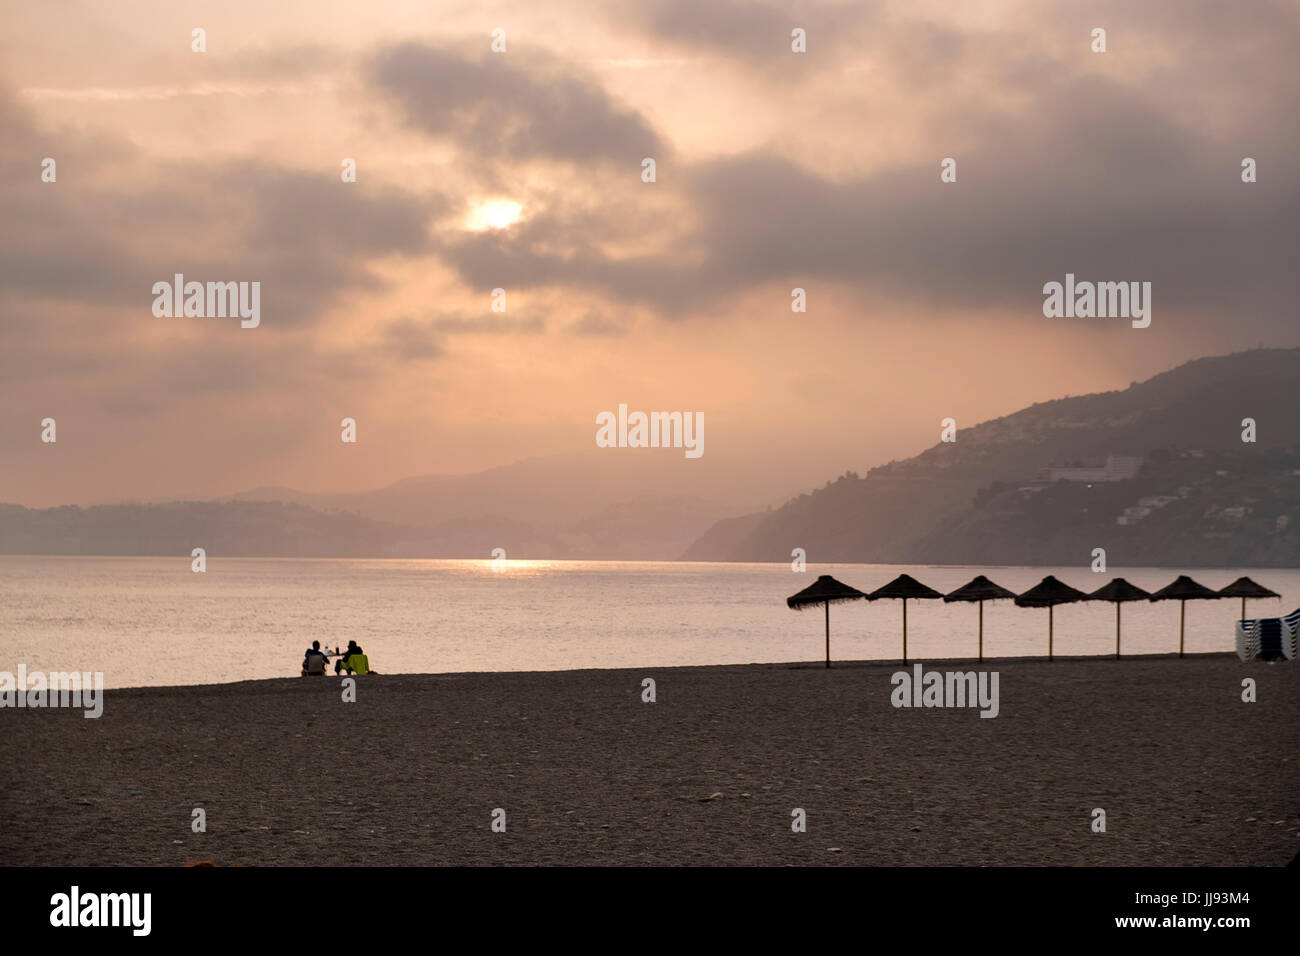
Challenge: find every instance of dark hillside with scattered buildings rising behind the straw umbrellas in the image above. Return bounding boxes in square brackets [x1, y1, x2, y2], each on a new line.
[683, 349, 1300, 567]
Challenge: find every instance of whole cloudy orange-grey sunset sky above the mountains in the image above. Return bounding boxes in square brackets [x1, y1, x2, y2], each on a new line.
[0, 0, 1300, 507]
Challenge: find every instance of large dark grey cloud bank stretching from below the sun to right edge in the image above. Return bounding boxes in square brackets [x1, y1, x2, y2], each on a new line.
[421, 54, 1300, 330]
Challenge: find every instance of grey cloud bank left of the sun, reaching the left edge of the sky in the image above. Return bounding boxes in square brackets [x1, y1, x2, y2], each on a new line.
[0, 89, 446, 326]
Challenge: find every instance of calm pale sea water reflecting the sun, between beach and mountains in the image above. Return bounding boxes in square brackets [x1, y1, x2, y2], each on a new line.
[0, 557, 1300, 687]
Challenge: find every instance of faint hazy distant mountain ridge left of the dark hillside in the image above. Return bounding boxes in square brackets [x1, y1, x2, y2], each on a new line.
[0, 450, 777, 561]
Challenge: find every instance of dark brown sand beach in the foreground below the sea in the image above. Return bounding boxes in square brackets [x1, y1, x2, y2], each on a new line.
[0, 656, 1300, 866]
